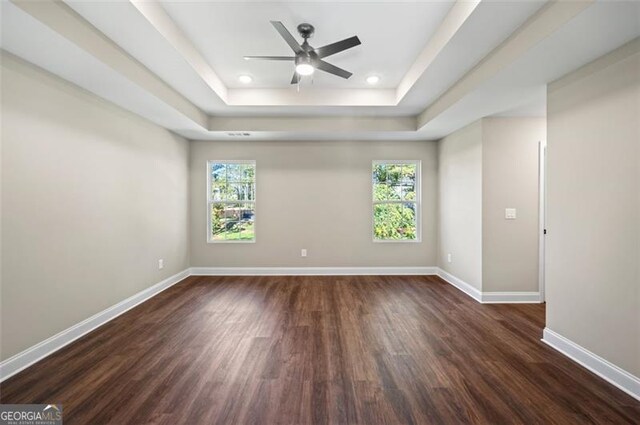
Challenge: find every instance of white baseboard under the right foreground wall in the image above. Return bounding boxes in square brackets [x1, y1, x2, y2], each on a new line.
[542, 328, 640, 400]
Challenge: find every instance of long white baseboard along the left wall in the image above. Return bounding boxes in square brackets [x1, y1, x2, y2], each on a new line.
[0, 269, 189, 382]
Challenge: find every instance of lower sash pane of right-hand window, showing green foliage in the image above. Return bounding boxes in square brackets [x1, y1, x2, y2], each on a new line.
[373, 203, 417, 240]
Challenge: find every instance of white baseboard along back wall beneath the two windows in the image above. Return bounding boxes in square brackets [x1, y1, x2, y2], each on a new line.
[190, 267, 438, 276]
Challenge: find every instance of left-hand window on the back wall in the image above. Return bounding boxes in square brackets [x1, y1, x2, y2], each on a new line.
[207, 161, 256, 242]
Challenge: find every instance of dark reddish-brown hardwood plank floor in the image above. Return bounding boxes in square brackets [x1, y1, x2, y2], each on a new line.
[0, 276, 640, 425]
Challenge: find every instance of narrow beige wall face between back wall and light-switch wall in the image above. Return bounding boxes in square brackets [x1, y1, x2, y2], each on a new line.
[438, 121, 482, 290]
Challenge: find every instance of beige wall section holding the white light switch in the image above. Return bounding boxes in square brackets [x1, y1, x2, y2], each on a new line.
[482, 117, 546, 292]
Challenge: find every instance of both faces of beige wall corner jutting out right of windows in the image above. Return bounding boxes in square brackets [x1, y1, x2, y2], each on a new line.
[438, 117, 546, 292]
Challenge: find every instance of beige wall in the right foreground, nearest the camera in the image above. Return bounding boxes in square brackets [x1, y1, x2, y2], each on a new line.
[546, 39, 640, 376]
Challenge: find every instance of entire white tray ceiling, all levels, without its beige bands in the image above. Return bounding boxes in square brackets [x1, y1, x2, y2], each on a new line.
[2, 0, 640, 140]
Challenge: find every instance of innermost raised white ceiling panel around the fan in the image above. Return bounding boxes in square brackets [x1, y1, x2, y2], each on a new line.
[162, 1, 453, 89]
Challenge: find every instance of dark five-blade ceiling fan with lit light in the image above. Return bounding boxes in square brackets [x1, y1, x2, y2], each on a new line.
[244, 21, 361, 84]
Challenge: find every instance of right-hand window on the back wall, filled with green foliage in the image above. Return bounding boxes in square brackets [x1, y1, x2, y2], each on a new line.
[372, 161, 420, 242]
